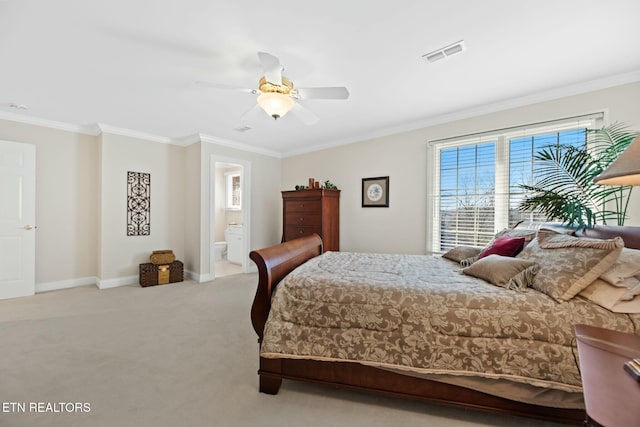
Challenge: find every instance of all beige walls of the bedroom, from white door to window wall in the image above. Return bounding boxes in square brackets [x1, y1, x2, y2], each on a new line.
[0, 83, 640, 287]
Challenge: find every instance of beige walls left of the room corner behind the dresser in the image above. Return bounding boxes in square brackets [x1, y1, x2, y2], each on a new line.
[0, 120, 281, 290]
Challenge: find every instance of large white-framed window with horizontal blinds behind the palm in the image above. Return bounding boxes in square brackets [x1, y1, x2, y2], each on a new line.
[427, 114, 602, 252]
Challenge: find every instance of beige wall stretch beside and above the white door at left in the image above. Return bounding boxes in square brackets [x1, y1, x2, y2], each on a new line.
[0, 120, 99, 283]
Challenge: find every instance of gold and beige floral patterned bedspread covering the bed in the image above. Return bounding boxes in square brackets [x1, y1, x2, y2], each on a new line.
[261, 252, 640, 391]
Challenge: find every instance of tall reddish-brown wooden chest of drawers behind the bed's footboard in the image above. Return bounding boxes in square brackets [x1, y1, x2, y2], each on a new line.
[282, 189, 340, 251]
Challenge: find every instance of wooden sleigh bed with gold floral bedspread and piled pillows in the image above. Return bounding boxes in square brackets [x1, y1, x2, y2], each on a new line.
[250, 223, 640, 424]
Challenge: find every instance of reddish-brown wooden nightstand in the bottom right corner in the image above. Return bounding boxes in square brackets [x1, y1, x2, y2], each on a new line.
[575, 325, 640, 427]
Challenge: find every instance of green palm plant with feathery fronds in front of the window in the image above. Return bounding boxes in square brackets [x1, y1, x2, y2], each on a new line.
[518, 123, 637, 228]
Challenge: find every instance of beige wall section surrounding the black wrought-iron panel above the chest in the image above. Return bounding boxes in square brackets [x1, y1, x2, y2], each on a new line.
[100, 133, 185, 287]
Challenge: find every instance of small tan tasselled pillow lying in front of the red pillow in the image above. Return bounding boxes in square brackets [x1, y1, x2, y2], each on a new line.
[462, 254, 538, 290]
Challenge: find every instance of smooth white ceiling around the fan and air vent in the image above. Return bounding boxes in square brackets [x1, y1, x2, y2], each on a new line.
[0, 0, 640, 155]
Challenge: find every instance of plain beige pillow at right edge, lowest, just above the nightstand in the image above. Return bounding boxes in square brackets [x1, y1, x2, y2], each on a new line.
[579, 279, 640, 313]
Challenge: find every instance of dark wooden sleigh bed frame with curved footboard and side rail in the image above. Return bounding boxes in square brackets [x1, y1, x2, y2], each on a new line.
[249, 225, 640, 424]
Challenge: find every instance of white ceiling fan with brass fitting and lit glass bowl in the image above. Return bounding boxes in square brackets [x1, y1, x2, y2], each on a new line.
[196, 52, 349, 124]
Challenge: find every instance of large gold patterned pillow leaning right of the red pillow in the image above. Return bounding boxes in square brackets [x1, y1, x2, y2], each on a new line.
[518, 230, 624, 302]
